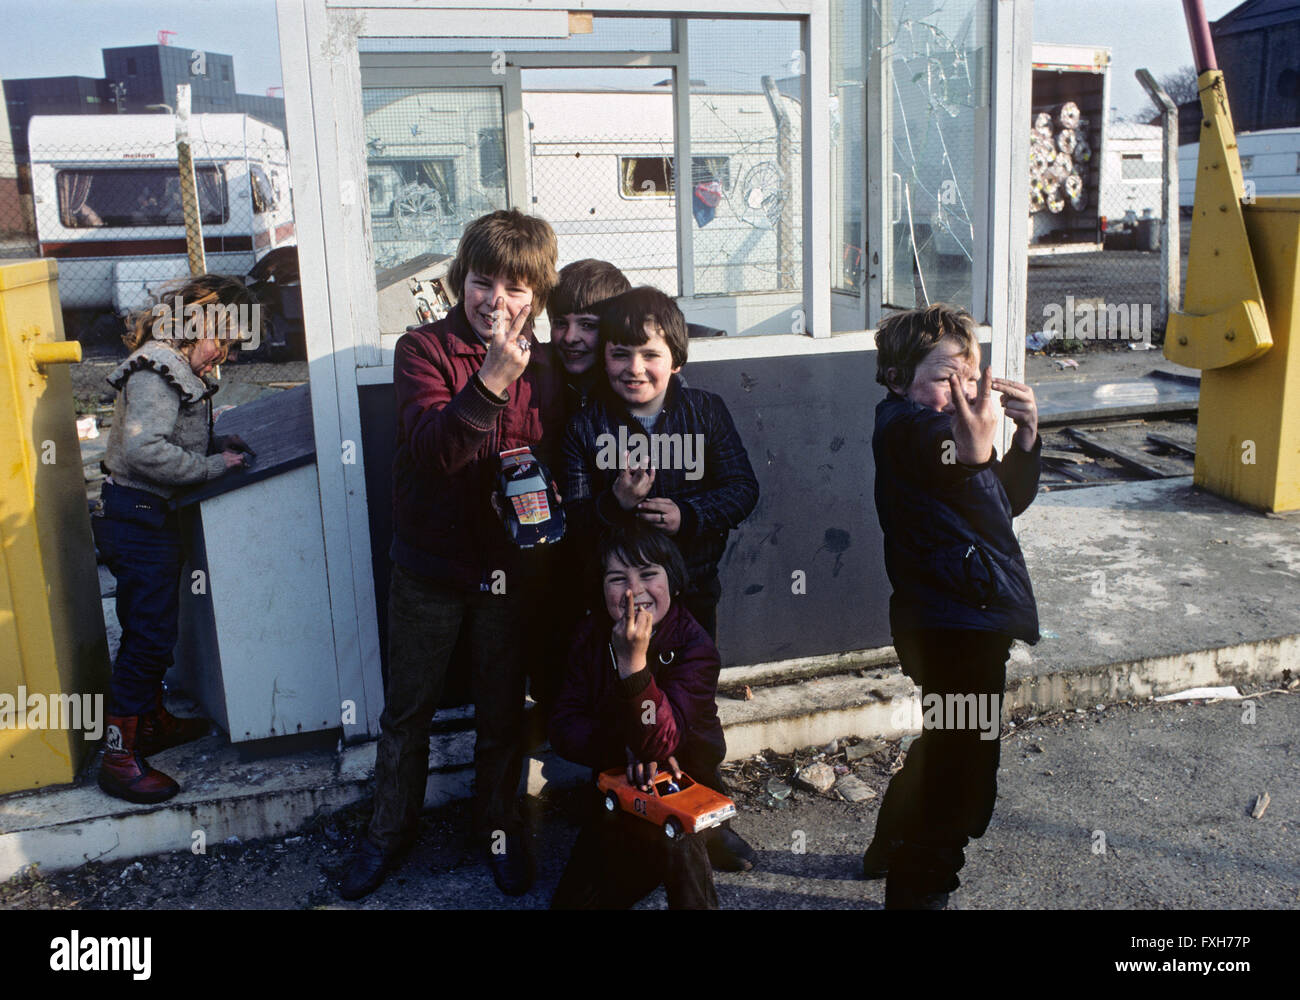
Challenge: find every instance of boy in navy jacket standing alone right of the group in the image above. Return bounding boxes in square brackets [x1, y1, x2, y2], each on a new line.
[863, 304, 1043, 909]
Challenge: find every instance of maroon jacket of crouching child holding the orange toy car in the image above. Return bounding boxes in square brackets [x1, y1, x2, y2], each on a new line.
[550, 603, 727, 784]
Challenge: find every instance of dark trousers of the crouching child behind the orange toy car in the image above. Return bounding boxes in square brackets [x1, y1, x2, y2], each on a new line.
[551, 791, 718, 910]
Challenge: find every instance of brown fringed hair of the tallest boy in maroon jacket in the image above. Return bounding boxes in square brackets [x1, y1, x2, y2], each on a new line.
[447, 208, 559, 319]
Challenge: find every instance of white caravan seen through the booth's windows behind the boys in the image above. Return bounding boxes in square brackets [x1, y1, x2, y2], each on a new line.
[365, 90, 802, 295]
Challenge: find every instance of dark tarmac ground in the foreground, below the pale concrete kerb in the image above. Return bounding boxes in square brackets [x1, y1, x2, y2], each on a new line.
[0, 693, 1300, 910]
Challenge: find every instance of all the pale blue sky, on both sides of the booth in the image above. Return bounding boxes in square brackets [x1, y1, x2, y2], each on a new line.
[0, 0, 1239, 116]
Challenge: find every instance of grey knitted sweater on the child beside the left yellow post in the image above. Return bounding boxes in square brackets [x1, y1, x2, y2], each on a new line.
[104, 341, 226, 499]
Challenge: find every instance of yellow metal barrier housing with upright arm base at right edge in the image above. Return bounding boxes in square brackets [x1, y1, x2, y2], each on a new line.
[1165, 69, 1300, 511]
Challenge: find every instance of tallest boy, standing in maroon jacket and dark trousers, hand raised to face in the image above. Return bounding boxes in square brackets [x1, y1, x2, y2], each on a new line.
[341, 211, 563, 899]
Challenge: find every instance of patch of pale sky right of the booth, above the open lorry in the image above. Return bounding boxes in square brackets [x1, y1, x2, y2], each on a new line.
[1034, 0, 1240, 116]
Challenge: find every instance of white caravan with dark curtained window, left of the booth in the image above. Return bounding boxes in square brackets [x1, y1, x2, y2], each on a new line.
[27, 114, 296, 312]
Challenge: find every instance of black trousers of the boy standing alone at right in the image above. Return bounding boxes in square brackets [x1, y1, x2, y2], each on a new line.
[875, 629, 1011, 892]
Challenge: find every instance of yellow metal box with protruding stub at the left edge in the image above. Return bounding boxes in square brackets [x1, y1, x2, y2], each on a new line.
[0, 260, 109, 793]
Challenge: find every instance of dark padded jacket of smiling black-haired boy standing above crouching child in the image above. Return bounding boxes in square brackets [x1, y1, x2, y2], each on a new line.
[559, 376, 758, 596]
